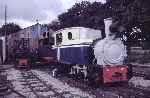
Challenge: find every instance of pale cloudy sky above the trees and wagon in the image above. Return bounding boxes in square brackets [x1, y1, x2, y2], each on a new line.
[0, 0, 105, 28]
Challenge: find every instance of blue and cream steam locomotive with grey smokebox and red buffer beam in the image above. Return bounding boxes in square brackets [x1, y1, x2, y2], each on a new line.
[53, 18, 132, 84]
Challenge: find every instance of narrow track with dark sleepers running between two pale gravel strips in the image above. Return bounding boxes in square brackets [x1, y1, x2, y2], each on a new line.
[21, 71, 65, 98]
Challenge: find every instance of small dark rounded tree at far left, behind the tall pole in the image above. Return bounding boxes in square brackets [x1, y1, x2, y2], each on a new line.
[0, 23, 21, 35]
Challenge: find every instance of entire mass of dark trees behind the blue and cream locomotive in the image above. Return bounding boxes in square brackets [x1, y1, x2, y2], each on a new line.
[49, 0, 150, 48]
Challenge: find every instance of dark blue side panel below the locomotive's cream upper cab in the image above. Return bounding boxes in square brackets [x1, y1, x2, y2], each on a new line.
[55, 45, 94, 65]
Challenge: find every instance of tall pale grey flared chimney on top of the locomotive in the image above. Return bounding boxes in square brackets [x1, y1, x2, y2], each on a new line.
[104, 18, 112, 37]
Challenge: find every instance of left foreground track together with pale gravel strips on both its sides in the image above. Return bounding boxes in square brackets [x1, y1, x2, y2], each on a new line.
[6, 68, 93, 98]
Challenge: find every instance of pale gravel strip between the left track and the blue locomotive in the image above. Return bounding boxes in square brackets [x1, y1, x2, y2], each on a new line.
[32, 70, 93, 98]
